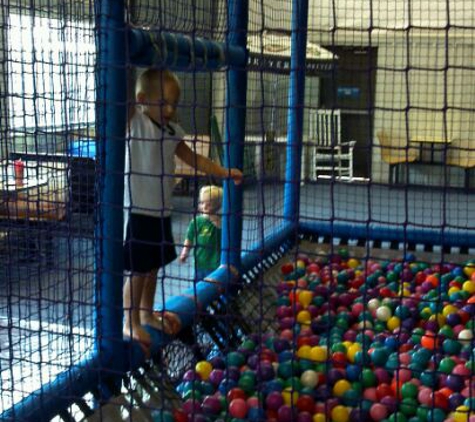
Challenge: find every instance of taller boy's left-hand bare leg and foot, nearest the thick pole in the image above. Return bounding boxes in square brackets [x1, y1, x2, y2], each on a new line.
[123, 275, 152, 347]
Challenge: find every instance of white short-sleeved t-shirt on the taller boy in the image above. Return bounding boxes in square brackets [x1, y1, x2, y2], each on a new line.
[124, 109, 185, 217]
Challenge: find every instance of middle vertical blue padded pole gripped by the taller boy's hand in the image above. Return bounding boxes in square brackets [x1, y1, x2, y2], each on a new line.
[221, 0, 248, 269]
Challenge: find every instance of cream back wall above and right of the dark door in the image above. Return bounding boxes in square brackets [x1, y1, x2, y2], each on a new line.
[309, 0, 475, 181]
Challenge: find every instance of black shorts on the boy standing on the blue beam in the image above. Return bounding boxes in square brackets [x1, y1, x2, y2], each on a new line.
[124, 214, 177, 273]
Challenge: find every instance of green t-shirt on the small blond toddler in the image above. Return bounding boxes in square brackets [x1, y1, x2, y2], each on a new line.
[186, 215, 221, 270]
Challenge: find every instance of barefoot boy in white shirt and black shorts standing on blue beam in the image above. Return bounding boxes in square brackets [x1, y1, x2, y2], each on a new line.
[123, 69, 242, 351]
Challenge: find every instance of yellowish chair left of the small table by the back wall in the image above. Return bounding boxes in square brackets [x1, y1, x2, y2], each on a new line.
[377, 131, 419, 184]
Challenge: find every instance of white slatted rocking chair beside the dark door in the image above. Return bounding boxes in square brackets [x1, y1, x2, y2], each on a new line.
[308, 109, 356, 180]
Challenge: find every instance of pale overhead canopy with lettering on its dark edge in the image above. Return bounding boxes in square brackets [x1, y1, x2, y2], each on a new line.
[247, 31, 338, 76]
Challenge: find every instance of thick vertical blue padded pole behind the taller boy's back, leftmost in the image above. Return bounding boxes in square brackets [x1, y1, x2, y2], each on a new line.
[96, 0, 127, 369]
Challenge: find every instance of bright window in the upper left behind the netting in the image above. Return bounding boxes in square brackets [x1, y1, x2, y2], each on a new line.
[8, 14, 96, 129]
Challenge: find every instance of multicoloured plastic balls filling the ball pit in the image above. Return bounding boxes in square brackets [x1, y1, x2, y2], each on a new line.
[173, 250, 475, 422]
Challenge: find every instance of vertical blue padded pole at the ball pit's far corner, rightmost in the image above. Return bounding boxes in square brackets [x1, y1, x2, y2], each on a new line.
[284, 0, 308, 226]
